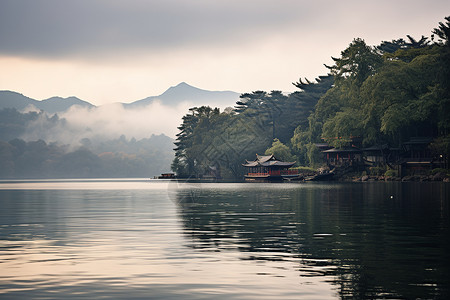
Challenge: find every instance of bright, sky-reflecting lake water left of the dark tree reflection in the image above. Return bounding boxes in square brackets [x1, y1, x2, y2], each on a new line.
[0, 183, 336, 300]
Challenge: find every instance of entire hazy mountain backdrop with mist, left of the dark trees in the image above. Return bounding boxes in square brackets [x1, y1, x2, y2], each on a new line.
[0, 82, 239, 178]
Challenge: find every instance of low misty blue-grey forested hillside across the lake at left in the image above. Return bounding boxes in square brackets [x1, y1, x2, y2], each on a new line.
[0, 109, 173, 178]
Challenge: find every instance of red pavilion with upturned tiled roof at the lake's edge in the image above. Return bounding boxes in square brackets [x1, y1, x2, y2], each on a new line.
[242, 154, 299, 181]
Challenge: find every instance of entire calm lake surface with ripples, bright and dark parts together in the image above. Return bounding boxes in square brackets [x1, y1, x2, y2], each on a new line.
[0, 179, 450, 299]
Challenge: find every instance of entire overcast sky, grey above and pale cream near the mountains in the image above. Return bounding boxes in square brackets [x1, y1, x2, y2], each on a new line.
[0, 0, 450, 105]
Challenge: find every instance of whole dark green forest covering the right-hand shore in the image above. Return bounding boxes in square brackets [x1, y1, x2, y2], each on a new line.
[172, 17, 450, 179]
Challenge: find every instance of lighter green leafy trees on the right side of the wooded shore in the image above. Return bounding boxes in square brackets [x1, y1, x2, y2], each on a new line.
[291, 17, 450, 164]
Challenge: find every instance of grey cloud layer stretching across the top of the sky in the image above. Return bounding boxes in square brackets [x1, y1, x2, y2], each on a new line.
[0, 0, 450, 63]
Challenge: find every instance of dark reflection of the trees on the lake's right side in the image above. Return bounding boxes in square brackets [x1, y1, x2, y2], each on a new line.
[177, 183, 450, 298]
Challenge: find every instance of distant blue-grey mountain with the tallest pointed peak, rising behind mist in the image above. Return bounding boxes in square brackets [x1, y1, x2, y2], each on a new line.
[124, 82, 240, 108]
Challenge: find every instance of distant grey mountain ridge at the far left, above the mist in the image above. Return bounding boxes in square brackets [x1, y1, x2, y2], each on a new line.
[0, 91, 94, 114]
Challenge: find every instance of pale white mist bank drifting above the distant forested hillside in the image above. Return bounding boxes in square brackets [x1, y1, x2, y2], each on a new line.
[22, 100, 197, 147]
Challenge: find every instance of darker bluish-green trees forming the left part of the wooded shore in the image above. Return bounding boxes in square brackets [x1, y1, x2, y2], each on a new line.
[172, 76, 333, 178]
